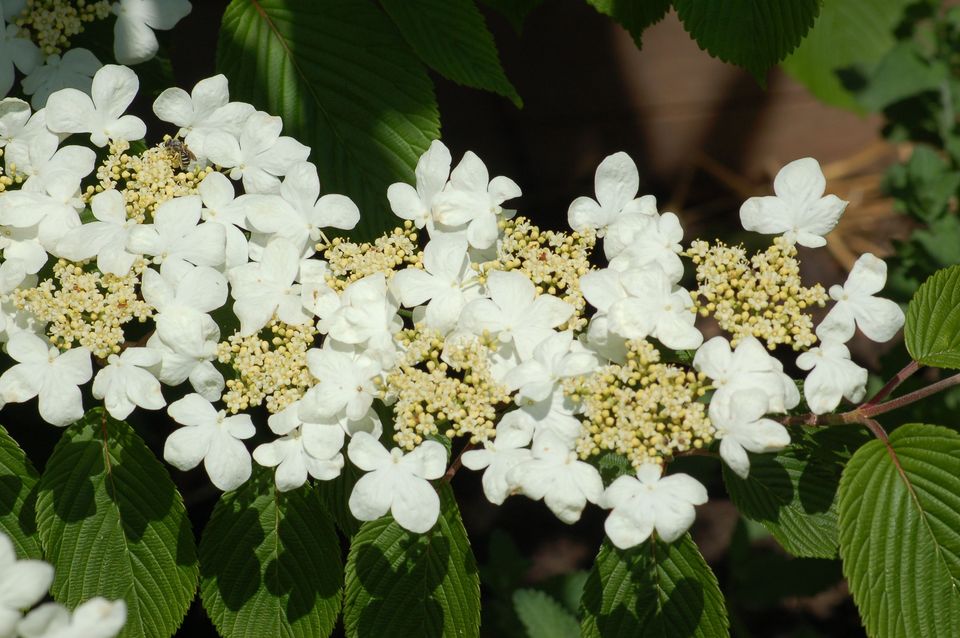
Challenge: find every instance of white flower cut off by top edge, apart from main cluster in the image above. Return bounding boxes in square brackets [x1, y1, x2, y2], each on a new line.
[112, 0, 192, 64]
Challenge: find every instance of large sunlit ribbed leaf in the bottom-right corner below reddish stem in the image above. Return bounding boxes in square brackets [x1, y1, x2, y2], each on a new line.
[840, 424, 960, 638]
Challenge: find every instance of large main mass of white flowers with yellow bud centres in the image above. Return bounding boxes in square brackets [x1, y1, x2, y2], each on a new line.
[0, 65, 903, 547]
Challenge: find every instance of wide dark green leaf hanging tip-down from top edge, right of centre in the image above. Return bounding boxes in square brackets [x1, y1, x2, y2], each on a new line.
[673, 0, 820, 84]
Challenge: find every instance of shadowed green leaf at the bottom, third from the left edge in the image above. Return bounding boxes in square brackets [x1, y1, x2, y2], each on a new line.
[200, 470, 343, 638]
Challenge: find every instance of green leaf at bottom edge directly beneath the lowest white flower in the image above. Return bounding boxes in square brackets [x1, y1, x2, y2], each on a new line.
[580, 534, 729, 638]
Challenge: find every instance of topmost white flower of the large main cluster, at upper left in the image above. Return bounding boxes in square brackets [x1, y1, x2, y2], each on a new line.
[46, 64, 147, 146]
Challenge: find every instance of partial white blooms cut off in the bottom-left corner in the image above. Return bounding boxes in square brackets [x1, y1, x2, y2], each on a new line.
[0, 534, 127, 638]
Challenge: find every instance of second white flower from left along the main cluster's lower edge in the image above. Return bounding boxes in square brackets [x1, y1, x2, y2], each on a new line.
[93, 348, 167, 420]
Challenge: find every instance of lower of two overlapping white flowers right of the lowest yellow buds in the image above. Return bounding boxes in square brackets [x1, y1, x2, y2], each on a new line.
[709, 390, 790, 478]
